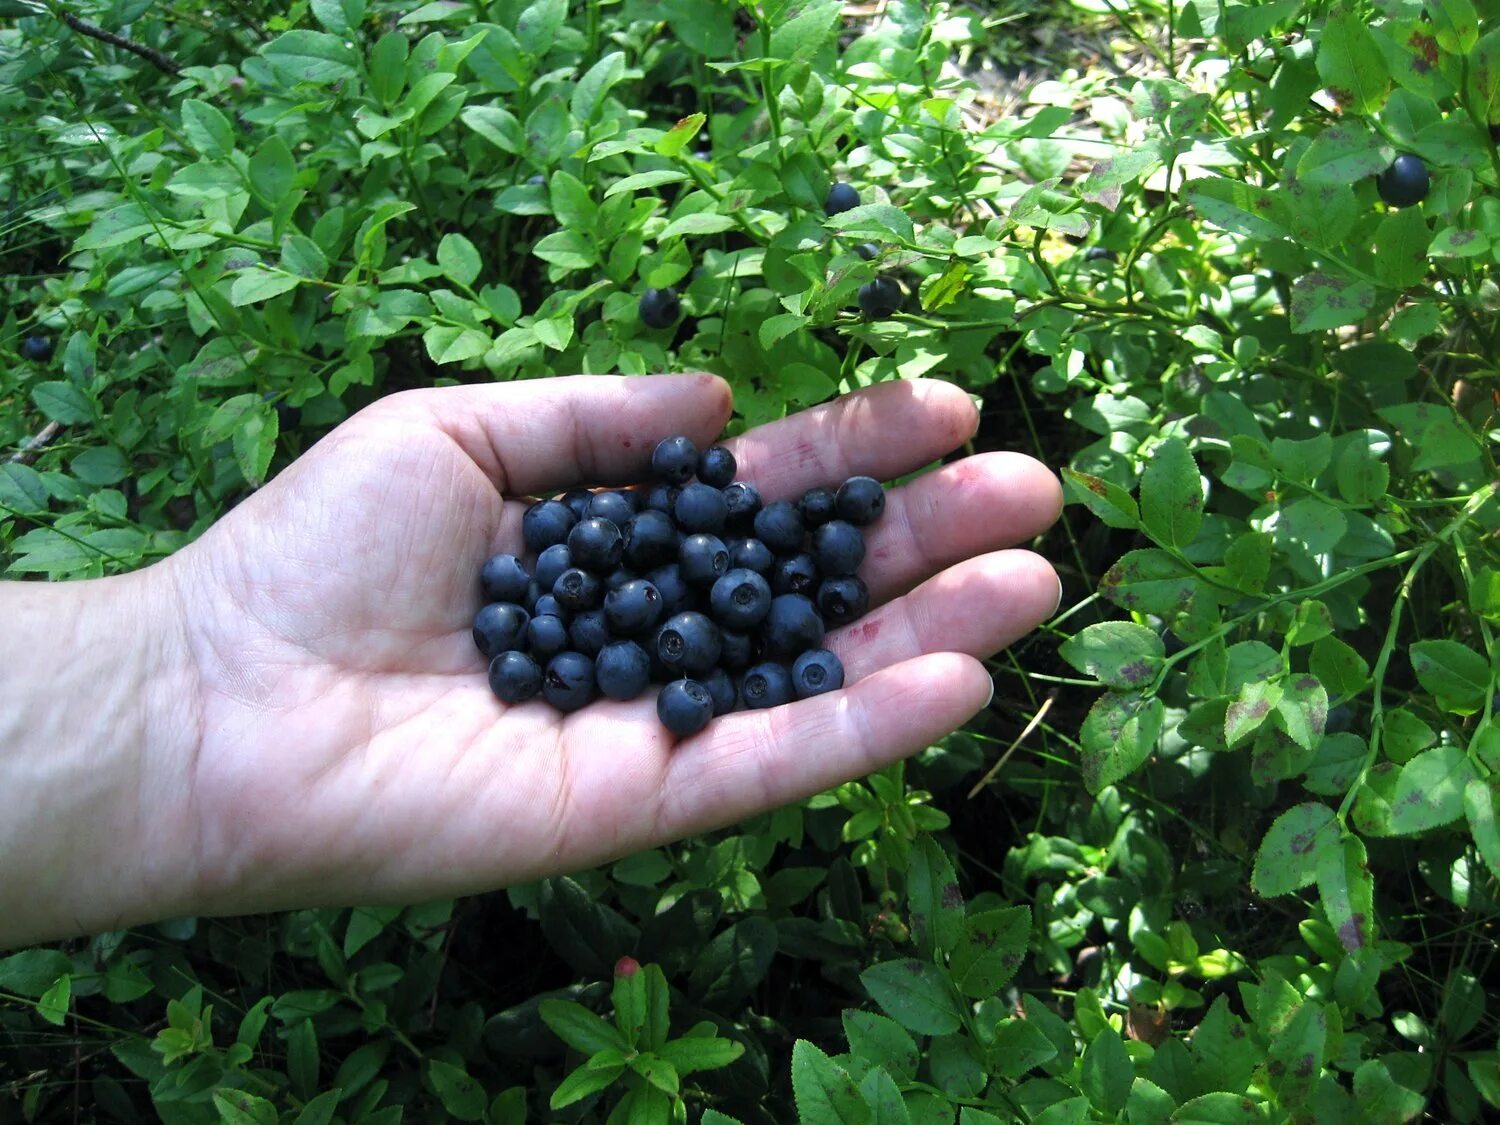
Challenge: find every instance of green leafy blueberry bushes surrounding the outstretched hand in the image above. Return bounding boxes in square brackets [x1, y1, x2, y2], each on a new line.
[0, 0, 1500, 1125]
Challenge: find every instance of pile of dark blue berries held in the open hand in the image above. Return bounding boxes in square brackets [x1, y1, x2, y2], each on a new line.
[474, 437, 885, 737]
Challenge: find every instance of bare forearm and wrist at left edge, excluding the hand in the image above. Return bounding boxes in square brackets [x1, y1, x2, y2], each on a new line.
[0, 567, 197, 950]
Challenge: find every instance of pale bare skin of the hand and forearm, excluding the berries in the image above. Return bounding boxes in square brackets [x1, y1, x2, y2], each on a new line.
[0, 375, 1062, 948]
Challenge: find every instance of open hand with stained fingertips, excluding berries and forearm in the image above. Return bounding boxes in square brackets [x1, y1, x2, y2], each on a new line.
[162, 375, 1061, 912]
